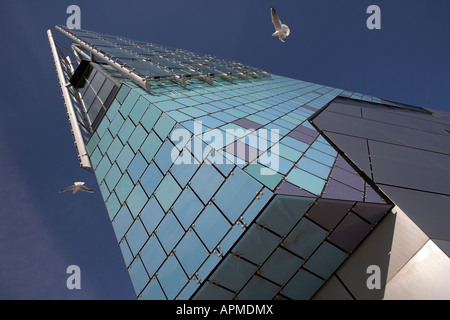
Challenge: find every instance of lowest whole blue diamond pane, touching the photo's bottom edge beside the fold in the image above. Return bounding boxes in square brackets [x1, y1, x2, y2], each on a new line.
[157, 252, 188, 300]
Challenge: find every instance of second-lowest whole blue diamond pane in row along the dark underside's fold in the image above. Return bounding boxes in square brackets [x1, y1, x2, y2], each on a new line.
[175, 230, 208, 277]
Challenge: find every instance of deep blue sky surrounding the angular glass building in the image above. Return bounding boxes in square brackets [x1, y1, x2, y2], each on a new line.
[0, 0, 450, 299]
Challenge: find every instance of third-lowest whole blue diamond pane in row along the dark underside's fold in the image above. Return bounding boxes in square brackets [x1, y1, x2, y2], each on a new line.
[194, 203, 230, 250]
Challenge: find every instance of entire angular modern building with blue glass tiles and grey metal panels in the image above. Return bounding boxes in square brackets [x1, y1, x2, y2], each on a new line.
[48, 26, 450, 300]
